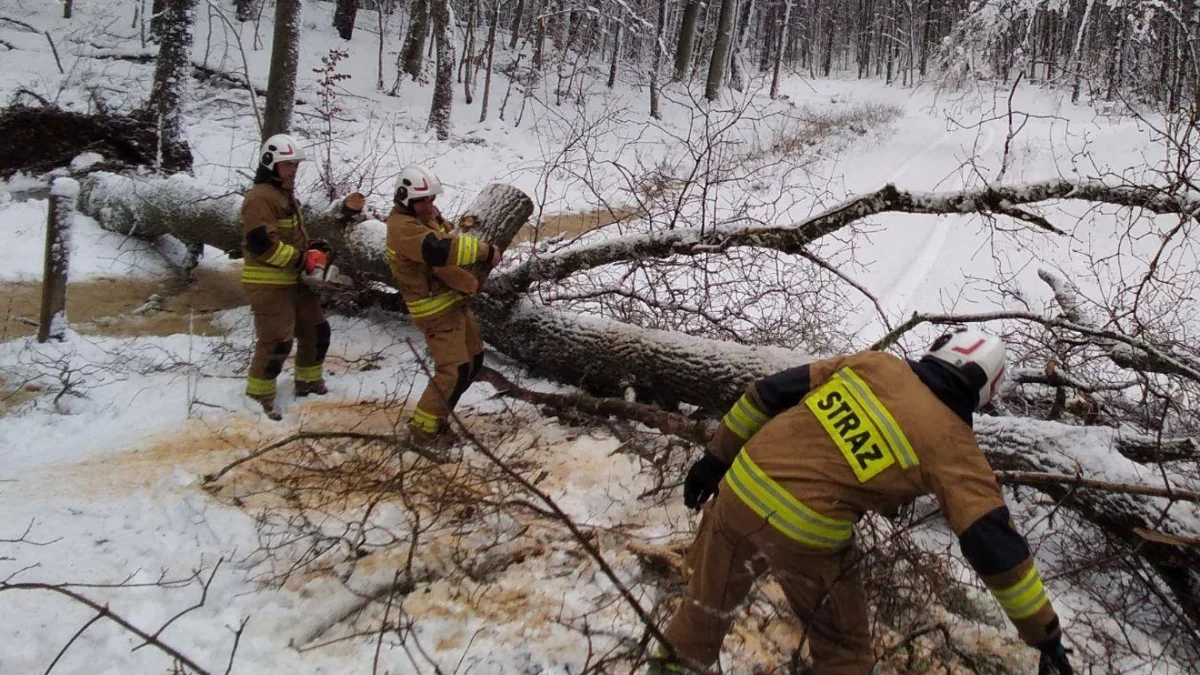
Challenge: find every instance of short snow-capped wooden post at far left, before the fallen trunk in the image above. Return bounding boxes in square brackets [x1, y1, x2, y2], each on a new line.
[37, 178, 79, 342]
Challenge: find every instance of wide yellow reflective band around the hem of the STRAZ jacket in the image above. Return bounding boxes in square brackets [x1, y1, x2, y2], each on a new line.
[725, 450, 854, 549]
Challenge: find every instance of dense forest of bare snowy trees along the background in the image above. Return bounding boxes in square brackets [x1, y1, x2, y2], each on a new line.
[324, 0, 1200, 107]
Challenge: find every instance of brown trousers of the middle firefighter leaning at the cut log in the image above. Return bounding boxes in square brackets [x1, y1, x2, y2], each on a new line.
[409, 305, 484, 434]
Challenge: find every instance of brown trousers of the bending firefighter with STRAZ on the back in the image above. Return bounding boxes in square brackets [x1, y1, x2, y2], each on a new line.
[665, 492, 875, 675]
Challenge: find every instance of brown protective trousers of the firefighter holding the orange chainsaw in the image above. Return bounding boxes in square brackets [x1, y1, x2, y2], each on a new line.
[242, 283, 330, 400]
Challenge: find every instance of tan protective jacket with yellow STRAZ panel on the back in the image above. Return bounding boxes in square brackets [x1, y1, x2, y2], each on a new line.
[709, 352, 1058, 644]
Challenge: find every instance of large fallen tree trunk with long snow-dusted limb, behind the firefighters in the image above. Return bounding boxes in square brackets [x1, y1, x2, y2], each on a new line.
[80, 169, 1200, 658]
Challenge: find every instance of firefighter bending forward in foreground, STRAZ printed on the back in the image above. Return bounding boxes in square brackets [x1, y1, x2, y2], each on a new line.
[654, 330, 1072, 675]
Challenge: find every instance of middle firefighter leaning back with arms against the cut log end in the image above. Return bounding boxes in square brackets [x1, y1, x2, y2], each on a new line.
[388, 166, 503, 444]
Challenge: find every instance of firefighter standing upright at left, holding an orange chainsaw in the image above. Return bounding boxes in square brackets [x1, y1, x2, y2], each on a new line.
[241, 133, 330, 420]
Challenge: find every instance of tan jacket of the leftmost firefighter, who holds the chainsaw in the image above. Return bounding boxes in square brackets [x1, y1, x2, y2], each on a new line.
[241, 183, 308, 286]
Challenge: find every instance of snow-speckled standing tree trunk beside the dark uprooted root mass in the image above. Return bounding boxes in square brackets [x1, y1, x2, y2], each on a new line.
[149, 0, 196, 171]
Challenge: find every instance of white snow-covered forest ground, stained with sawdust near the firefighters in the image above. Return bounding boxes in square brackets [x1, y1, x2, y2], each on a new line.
[0, 0, 1195, 674]
